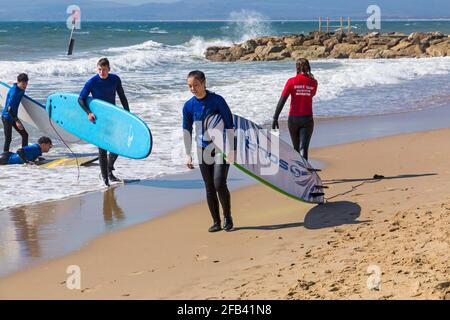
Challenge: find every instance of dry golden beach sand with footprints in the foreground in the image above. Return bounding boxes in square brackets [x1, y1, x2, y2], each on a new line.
[0, 129, 450, 299]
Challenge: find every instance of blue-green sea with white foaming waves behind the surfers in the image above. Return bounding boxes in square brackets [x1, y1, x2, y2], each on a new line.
[0, 15, 450, 209]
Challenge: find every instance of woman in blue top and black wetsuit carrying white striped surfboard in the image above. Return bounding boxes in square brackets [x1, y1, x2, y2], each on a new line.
[183, 70, 233, 232]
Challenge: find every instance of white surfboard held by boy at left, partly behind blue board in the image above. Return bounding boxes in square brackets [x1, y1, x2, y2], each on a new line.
[0, 81, 83, 143]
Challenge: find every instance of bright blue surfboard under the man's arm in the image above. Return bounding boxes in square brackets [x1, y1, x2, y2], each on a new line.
[46, 93, 152, 159]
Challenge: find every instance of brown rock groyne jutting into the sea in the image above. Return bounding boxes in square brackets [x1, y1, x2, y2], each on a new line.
[205, 31, 450, 62]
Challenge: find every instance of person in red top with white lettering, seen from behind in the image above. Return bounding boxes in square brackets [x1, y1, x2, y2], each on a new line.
[272, 58, 317, 160]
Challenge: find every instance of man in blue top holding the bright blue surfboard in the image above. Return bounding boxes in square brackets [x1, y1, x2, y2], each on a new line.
[78, 58, 130, 186]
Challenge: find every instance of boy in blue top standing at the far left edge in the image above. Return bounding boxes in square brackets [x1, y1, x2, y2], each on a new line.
[2, 73, 28, 152]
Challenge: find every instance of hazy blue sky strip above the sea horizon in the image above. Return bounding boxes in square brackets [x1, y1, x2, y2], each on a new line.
[0, 0, 450, 21]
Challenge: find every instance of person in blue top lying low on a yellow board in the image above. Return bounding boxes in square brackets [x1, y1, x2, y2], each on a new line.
[0, 137, 53, 165]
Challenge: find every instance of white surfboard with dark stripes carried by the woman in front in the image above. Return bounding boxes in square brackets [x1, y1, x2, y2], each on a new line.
[202, 114, 325, 203]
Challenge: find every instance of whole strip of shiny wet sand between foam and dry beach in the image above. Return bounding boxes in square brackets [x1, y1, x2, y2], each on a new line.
[0, 101, 450, 278]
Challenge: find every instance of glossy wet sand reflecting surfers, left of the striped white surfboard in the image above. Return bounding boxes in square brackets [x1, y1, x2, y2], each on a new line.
[0, 170, 254, 277]
